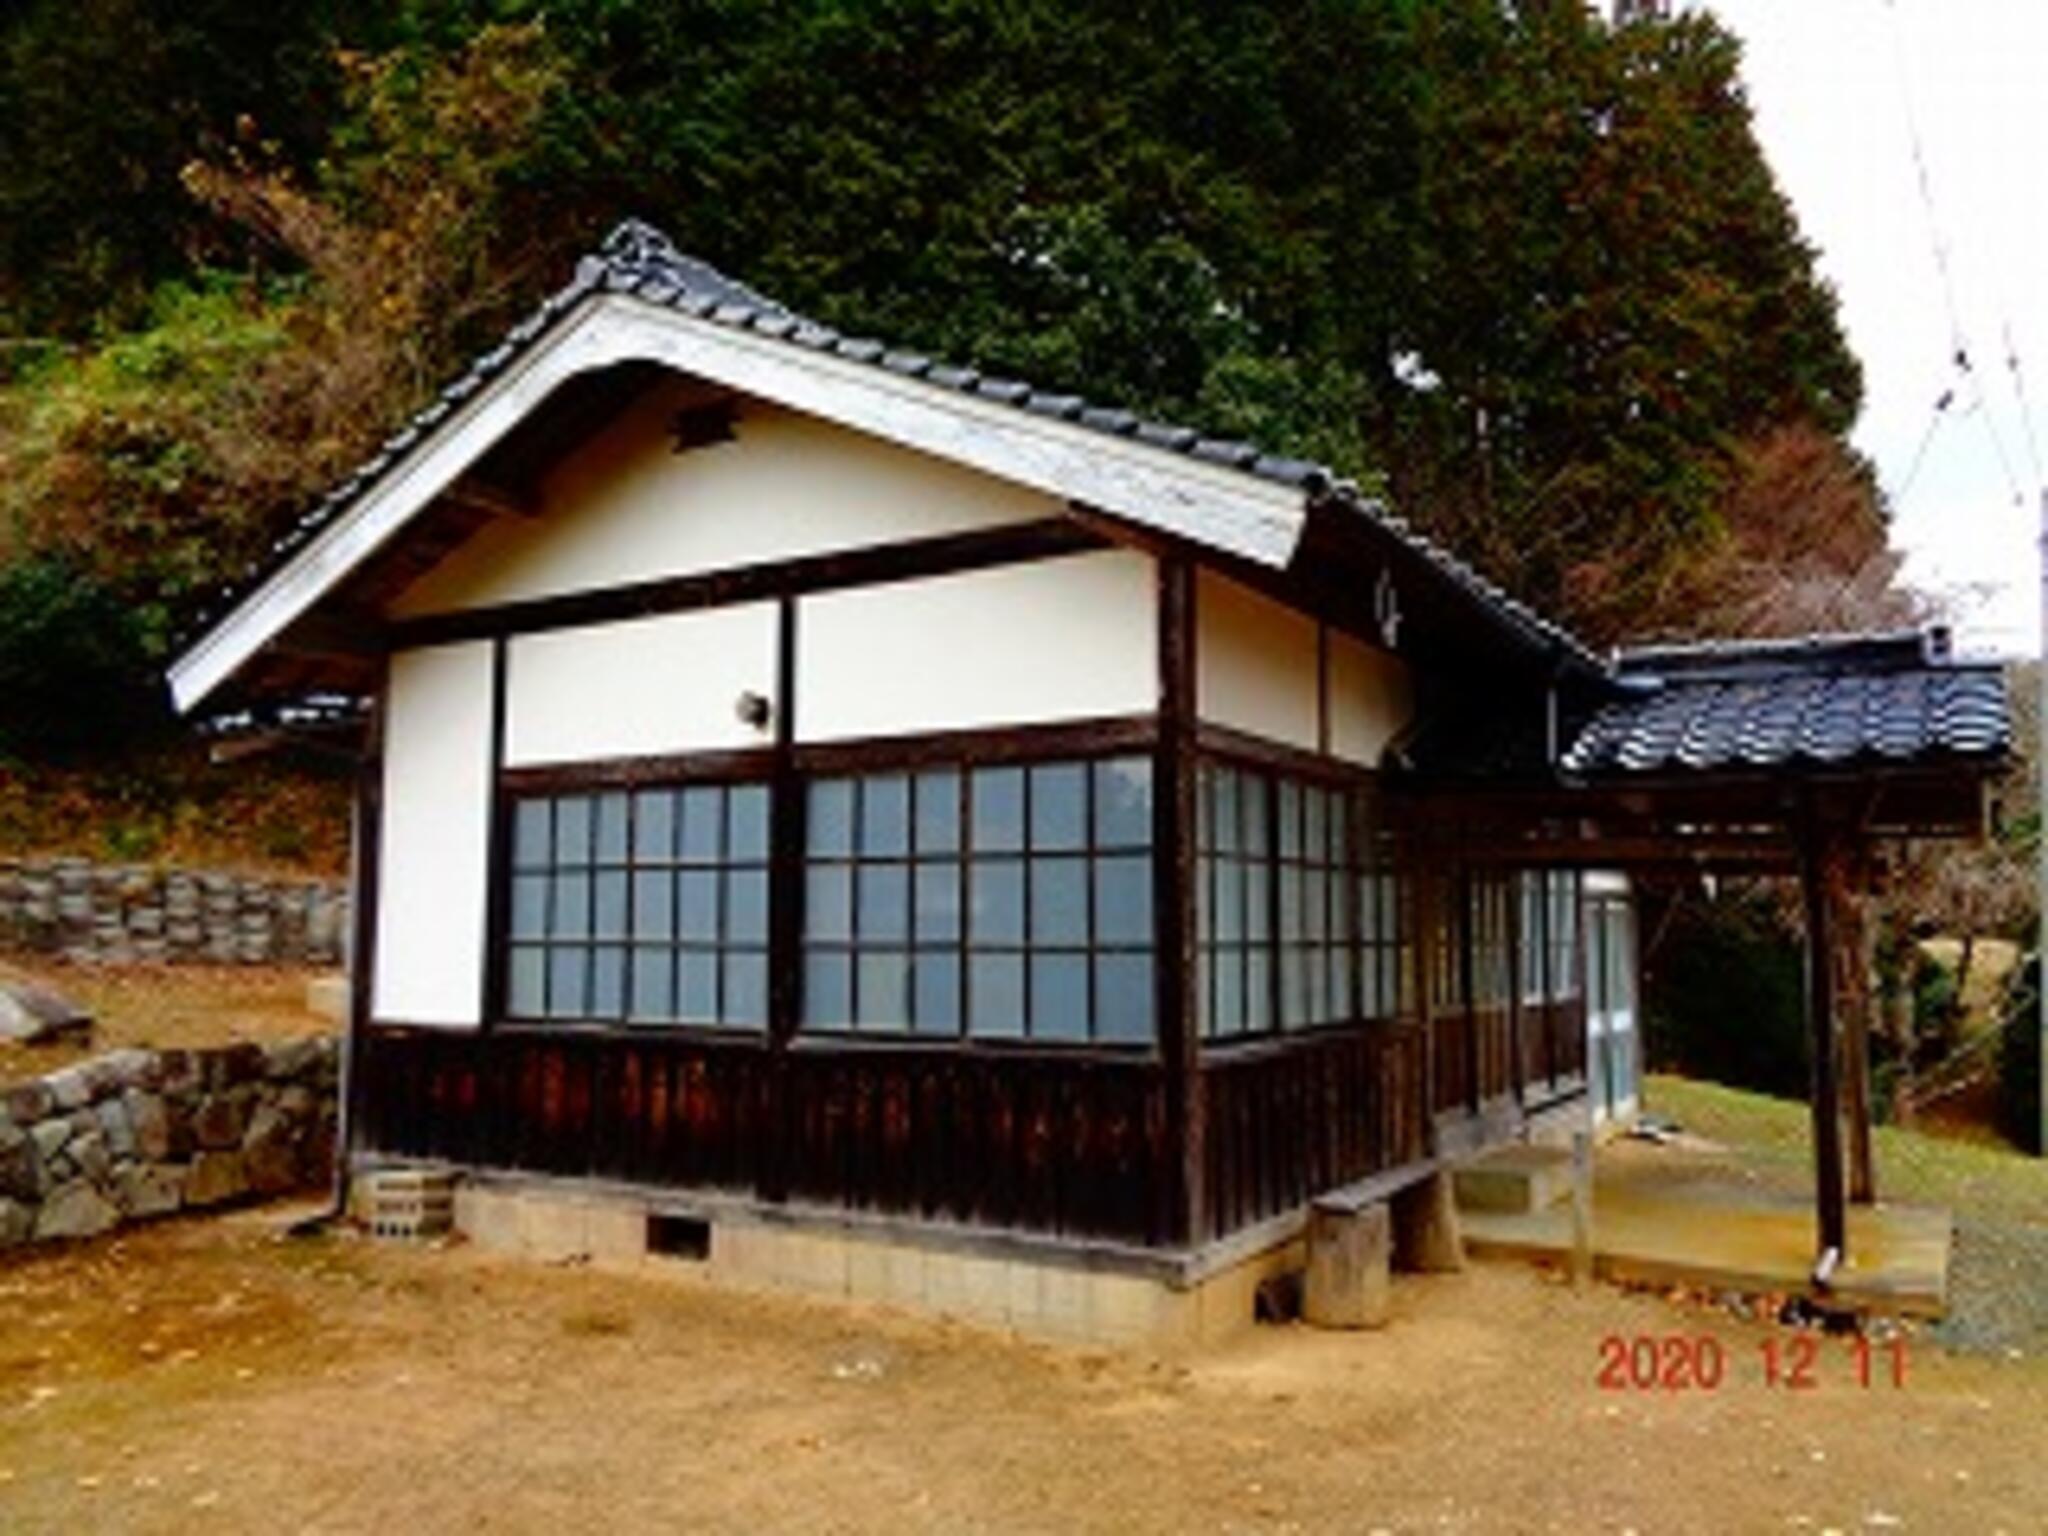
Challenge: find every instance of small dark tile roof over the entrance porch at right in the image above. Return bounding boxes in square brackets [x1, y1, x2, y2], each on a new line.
[1561, 631, 2011, 776]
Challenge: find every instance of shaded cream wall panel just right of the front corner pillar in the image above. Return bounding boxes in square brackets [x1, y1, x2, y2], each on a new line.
[1194, 571, 1319, 752]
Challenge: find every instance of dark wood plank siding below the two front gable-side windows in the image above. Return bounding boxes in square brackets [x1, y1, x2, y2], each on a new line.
[354, 1026, 1180, 1247]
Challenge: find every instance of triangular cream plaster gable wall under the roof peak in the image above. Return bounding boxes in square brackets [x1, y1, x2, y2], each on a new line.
[393, 379, 1063, 616]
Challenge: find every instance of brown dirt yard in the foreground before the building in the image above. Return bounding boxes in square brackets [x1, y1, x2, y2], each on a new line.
[0, 1208, 2048, 1536]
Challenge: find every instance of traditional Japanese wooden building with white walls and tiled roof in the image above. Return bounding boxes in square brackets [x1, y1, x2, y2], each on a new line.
[172, 223, 2007, 1343]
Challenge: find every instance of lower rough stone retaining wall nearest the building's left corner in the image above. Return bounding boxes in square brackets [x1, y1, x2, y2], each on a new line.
[0, 1038, 340, 1249]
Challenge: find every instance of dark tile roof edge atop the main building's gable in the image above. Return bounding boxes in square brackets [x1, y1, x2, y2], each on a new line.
[193, 219, 1602, 672]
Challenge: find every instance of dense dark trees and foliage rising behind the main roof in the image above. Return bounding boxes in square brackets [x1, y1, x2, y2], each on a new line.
[0, 0, 1860, 663]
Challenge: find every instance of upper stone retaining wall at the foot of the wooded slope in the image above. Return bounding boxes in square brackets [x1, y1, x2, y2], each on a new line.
[0, 858, 348, 965]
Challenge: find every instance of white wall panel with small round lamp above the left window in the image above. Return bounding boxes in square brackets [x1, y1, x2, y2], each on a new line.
[506, 602, 780, 768]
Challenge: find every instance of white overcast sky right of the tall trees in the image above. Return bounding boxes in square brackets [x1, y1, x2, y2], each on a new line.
[1706, 0, 2048, 651]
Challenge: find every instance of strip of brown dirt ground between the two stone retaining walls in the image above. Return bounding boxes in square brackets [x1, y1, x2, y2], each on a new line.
[0, 954, 336, 1083]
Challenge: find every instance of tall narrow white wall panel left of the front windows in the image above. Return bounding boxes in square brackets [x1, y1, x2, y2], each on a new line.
[371, 641, 492, 1026]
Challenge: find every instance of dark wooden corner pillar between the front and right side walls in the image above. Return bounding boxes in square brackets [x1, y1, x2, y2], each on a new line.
[1153, 555, 1210, 1245]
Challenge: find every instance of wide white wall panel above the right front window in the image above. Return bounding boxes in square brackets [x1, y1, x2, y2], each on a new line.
[797, 549, 1159, 741]
